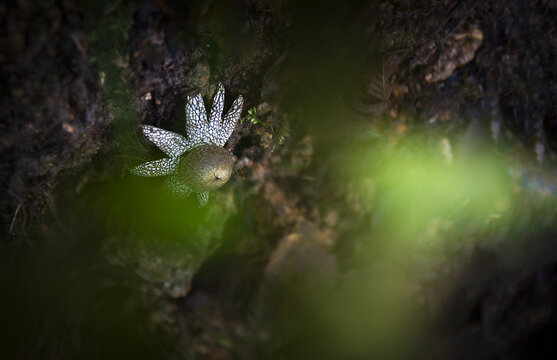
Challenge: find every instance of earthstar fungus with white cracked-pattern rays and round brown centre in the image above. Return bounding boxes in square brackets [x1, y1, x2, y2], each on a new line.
[131, 84, 244, 206]
